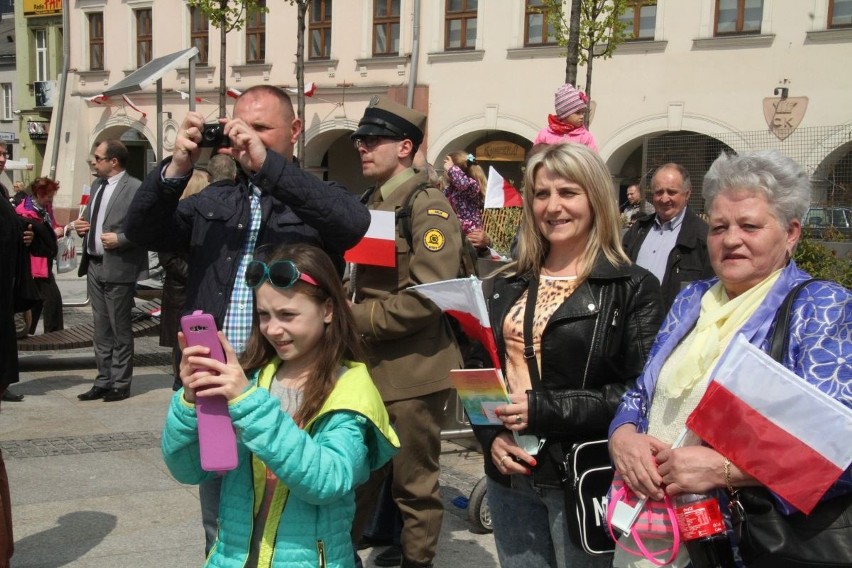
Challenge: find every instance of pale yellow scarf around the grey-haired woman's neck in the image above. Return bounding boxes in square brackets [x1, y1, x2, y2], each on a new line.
[660, 269, 781, 398]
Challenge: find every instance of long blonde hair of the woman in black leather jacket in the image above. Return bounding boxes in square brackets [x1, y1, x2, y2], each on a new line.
[514, 144, 630, 280]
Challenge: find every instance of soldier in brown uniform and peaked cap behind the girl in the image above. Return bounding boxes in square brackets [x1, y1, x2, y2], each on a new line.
[349, 96, 462, 567]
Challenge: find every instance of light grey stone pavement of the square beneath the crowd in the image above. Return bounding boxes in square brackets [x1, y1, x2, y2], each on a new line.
[5, 304, 497, 568]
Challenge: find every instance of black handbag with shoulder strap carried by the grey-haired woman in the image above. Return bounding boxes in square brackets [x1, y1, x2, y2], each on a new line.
[732, 280, 852, 568]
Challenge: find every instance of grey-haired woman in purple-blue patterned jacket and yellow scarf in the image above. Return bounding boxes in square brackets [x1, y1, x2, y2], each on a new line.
[610, 151, 852, 566]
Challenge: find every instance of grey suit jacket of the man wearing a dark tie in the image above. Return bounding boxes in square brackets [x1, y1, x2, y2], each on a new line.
[77, 172, 148, 284]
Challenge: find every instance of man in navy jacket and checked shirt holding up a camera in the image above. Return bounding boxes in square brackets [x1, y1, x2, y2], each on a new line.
[127, 85, 370, 550]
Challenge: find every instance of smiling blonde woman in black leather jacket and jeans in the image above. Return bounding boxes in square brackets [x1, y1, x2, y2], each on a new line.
[475, 144, 663, 568]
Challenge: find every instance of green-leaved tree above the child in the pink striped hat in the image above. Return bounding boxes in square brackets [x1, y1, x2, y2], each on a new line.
[542, 0, 627, 100]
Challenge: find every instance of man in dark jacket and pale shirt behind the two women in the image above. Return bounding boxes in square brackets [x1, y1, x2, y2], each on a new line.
[623, 163, 713, 310]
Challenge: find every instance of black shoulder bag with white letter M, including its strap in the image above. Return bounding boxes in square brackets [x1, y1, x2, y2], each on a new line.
[524, 276, 615, 556]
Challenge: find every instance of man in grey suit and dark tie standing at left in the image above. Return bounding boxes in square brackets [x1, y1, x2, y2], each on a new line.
[74, 140, 148, 402]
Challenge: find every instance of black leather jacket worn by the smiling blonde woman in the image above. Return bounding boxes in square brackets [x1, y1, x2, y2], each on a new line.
[474, 255, 664, 486]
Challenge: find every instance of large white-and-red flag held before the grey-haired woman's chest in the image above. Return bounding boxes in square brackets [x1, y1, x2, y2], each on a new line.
[686, 335, 852, 514]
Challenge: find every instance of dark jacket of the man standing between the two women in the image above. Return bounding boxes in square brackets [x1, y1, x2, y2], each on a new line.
[623, 209, 714, 311]
